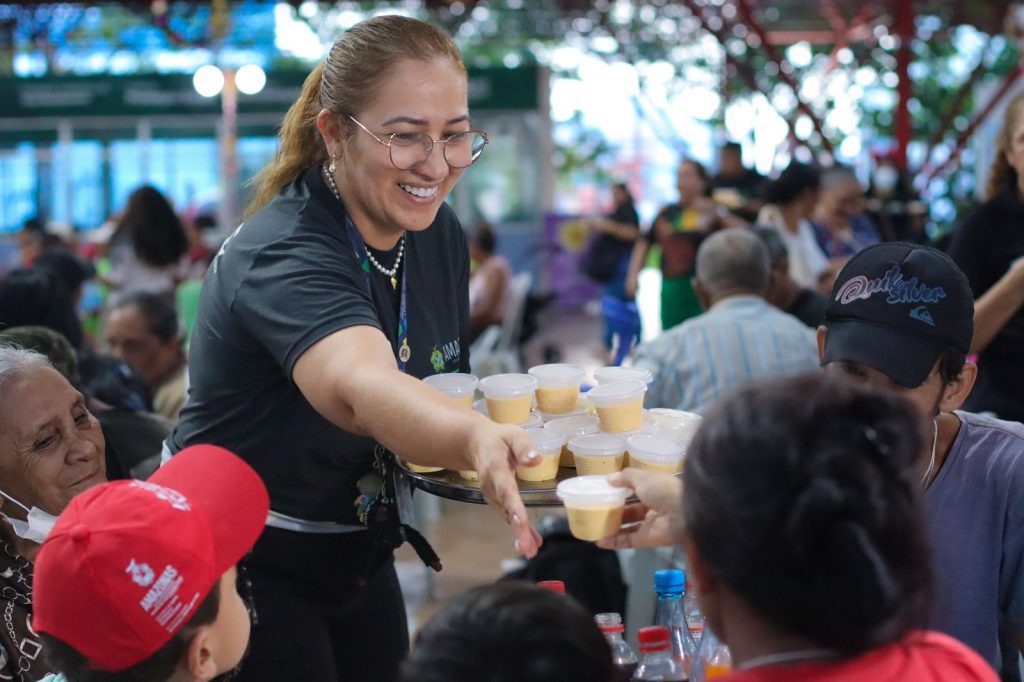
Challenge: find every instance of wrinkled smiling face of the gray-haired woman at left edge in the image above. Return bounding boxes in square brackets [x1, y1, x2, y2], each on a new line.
[0, 368, 106, 518]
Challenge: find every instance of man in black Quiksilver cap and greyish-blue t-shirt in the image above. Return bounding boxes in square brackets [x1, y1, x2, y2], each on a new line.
[818, 243, 1024, 679]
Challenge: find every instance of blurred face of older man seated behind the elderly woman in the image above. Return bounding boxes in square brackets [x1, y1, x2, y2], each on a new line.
[104, 305, 181, 387]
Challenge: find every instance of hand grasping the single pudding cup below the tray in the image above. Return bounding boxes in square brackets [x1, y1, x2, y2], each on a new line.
[597, 469, 683, 549]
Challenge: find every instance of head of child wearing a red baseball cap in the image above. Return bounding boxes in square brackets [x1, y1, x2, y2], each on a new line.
[33, 445, 269, 682]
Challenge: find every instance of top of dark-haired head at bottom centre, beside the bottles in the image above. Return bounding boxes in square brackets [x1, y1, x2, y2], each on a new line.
[401, 581, 612, 682]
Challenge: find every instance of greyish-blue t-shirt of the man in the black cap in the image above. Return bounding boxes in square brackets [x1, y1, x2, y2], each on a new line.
[925, 412, 1024, 670]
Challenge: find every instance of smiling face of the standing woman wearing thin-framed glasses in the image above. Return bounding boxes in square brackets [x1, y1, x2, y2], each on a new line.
[328, 58, 471, 241]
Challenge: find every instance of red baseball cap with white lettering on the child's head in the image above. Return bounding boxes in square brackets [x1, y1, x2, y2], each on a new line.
[32, 445, 269, 672]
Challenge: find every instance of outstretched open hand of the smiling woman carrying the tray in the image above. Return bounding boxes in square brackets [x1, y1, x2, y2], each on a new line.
[470, 419, 541, 558]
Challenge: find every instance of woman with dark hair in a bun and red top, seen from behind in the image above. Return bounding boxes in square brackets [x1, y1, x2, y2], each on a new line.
[604, 375, 997, 682]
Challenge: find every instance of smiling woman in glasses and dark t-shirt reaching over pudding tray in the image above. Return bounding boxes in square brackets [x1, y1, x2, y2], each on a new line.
[168, 16, 541, 682]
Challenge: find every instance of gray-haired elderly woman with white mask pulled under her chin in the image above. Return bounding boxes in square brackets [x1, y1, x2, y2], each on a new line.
[0, 346, 106, 680]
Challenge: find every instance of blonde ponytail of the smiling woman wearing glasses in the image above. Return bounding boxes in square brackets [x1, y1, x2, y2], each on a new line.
[245, 62, 327, 218]
